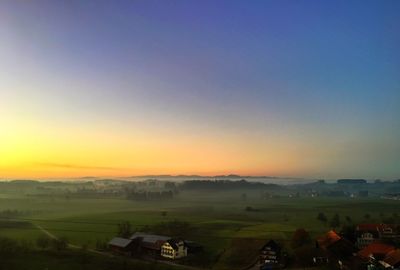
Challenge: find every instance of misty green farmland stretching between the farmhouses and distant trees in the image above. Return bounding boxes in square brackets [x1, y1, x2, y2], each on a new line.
[0, 187, 400, 269]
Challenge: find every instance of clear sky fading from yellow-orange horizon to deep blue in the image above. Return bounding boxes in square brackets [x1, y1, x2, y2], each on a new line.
[0, 0, 400, 179]
